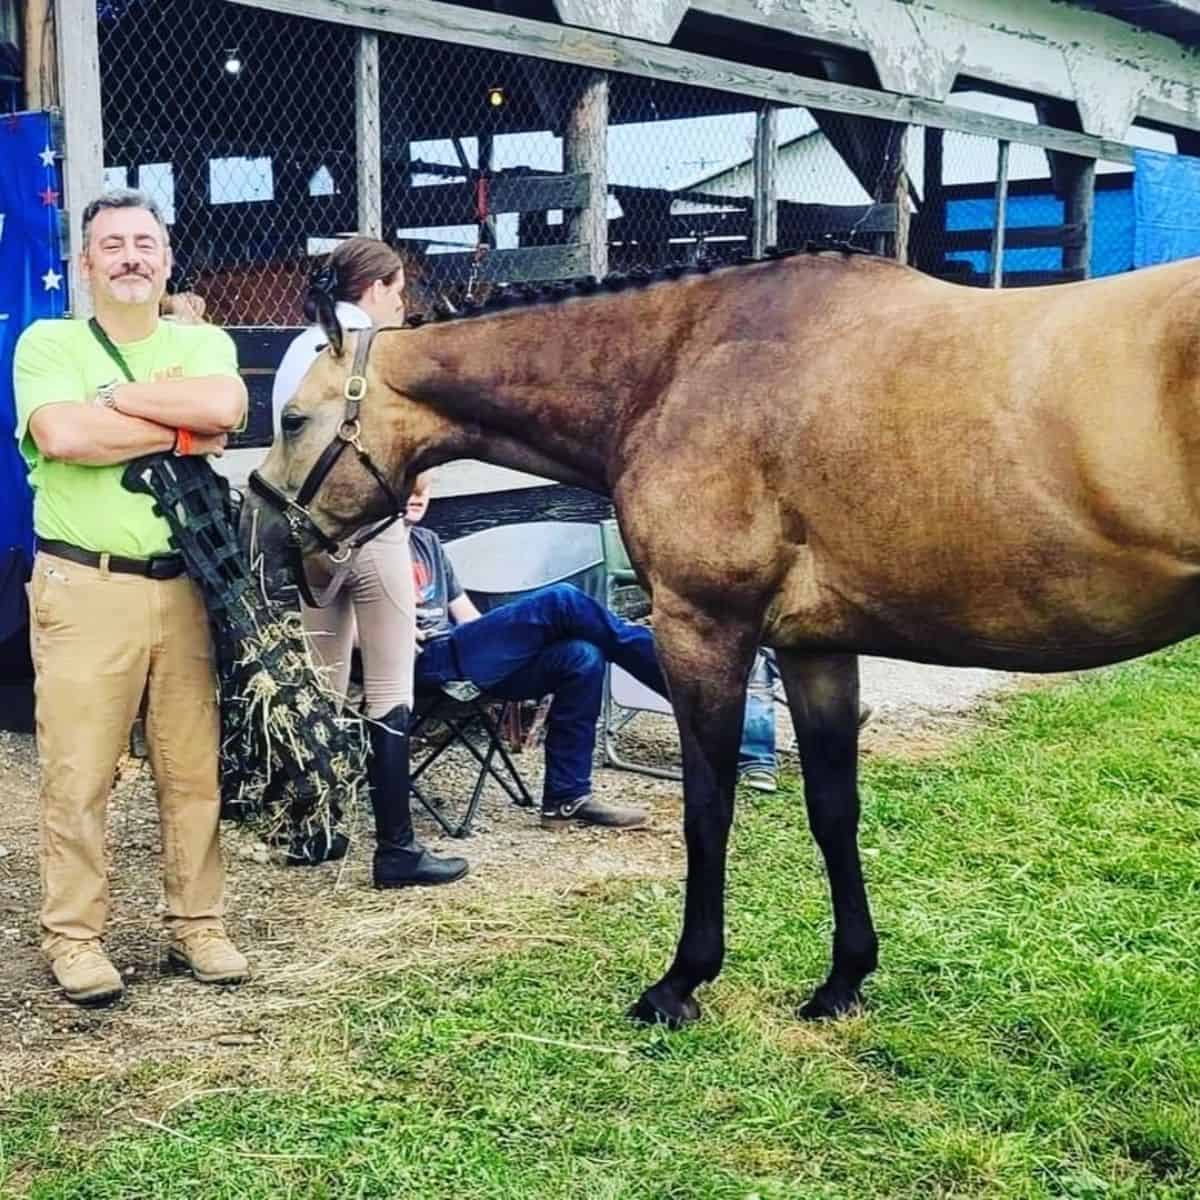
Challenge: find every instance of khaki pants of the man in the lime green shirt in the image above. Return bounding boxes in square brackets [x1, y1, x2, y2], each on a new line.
[30, 553, 224, 958]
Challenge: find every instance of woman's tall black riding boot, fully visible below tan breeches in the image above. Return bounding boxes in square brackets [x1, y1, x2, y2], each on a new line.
[367, 704, 467, 888]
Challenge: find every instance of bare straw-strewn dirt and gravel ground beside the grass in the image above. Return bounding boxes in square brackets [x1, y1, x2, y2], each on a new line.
[0, 660, 1021, 1099]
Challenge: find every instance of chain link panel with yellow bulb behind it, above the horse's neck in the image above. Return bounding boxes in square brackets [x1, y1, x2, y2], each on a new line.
[380, 37, 604, 307]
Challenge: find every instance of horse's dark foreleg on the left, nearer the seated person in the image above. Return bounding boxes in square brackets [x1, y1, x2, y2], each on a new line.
[630, 595, 756, 1028]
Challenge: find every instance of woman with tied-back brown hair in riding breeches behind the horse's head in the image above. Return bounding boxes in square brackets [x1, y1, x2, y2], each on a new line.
[271, 238, 467, 888]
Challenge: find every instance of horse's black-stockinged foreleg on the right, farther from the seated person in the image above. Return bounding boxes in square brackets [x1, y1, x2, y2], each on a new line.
[775, 649, 878, 1019]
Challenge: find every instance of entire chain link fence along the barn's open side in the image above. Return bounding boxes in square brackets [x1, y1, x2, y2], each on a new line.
[93, 0, 1133, 326]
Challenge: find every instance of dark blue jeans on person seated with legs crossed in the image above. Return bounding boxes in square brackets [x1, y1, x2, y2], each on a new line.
[415, 583, 774, 808]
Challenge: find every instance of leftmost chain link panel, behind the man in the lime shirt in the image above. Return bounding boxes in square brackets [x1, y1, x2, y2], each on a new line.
[100, 0, 356, 325]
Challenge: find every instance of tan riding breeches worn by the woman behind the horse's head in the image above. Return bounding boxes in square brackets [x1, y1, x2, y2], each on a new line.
[304, 521, 416, 718]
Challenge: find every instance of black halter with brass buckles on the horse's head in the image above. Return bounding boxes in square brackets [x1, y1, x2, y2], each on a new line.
[250, 326, 404, 608]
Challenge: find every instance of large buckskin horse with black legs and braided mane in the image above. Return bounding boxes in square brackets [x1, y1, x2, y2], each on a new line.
[246, 253, 1200, 1025]
